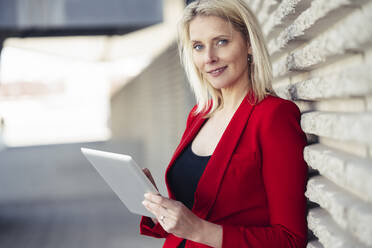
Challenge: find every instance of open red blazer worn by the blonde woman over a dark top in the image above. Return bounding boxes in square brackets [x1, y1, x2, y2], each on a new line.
[140, 95, 307, 248]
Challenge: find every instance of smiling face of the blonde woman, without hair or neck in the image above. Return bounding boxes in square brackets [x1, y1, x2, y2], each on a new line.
[189, 16, 249, 89]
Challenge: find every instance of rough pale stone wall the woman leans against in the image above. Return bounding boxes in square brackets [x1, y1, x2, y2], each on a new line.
[247, 0, 372, 248]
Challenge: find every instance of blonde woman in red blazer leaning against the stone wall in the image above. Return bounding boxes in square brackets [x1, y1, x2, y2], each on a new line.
[140, 0, 307, 248]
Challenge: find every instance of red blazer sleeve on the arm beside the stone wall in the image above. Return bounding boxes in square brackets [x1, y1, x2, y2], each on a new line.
[222, 101, 307, 248]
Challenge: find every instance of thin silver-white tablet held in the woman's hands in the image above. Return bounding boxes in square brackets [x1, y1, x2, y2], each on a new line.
[81, 148, 158, 217]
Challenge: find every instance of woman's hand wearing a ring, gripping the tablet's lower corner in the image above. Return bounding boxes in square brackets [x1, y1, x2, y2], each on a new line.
[142, 193, 203, 241]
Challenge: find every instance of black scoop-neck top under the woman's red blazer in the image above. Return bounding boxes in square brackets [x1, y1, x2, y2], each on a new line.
[168, 142, 211, 248]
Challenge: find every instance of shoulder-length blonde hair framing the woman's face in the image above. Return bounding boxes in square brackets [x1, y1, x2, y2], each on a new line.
[178, 0, 275, 116]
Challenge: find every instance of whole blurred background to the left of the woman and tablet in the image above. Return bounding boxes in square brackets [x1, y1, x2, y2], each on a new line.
[0, 0, 193, 248]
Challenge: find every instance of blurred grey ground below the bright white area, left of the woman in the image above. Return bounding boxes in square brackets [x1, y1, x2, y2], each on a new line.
[0, 141, 164, 248]
